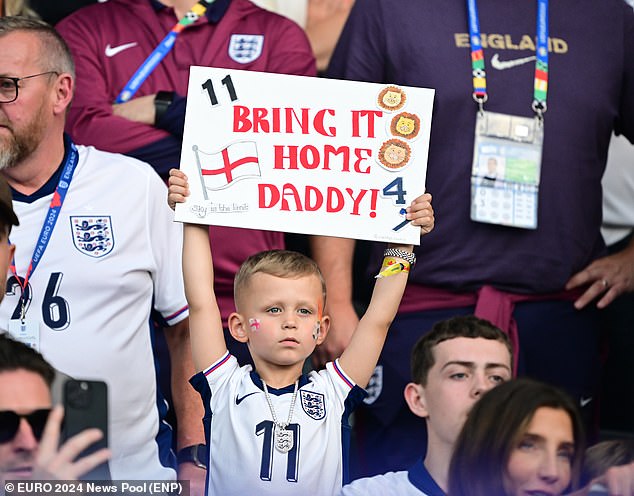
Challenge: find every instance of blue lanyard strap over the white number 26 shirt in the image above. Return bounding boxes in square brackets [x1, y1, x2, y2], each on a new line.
[10, 143, 79, 320]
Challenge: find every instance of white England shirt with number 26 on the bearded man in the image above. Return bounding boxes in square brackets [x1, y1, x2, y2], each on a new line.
[0, 141, 188, 479]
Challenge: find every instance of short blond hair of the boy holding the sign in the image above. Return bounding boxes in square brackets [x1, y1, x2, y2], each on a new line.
[233, 250, 326, 306]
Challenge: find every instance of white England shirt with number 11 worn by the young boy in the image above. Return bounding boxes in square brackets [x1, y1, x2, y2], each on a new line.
[192, 353, 365, 496]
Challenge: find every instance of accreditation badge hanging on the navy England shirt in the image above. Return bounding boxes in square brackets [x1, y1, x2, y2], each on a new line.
[471, 111, 544, 229]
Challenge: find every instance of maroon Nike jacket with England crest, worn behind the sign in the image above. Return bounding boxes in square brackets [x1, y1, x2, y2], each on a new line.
[57, 0, 316, 157]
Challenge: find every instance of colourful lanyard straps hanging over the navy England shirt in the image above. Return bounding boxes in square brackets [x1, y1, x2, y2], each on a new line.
[467, 0, 548, 119]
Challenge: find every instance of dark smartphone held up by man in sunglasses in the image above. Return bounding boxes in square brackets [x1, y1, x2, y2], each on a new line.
[62, 379, 112, 480]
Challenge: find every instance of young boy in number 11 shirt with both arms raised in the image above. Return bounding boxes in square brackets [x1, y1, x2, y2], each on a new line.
[169, 170, 434, 496]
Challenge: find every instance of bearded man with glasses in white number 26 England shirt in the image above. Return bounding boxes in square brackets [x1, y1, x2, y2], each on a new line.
[0, 17, 205, 494]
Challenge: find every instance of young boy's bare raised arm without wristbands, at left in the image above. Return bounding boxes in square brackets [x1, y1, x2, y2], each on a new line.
[168, 170, 227, 372]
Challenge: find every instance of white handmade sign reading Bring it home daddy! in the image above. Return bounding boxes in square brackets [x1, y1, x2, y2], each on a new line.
[176, 67, 434, 244]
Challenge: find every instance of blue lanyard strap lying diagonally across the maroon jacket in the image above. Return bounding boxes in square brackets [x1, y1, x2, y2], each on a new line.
[116, 0, 216, 103]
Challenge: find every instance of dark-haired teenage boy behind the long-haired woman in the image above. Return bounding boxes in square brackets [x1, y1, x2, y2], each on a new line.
[341, 316, 513, 496]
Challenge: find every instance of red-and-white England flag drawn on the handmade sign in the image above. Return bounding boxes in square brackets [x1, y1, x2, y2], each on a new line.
[192, 141, 261, 196]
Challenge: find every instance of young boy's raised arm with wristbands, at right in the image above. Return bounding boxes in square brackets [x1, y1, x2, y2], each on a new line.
[339, 193, 434, 388]
